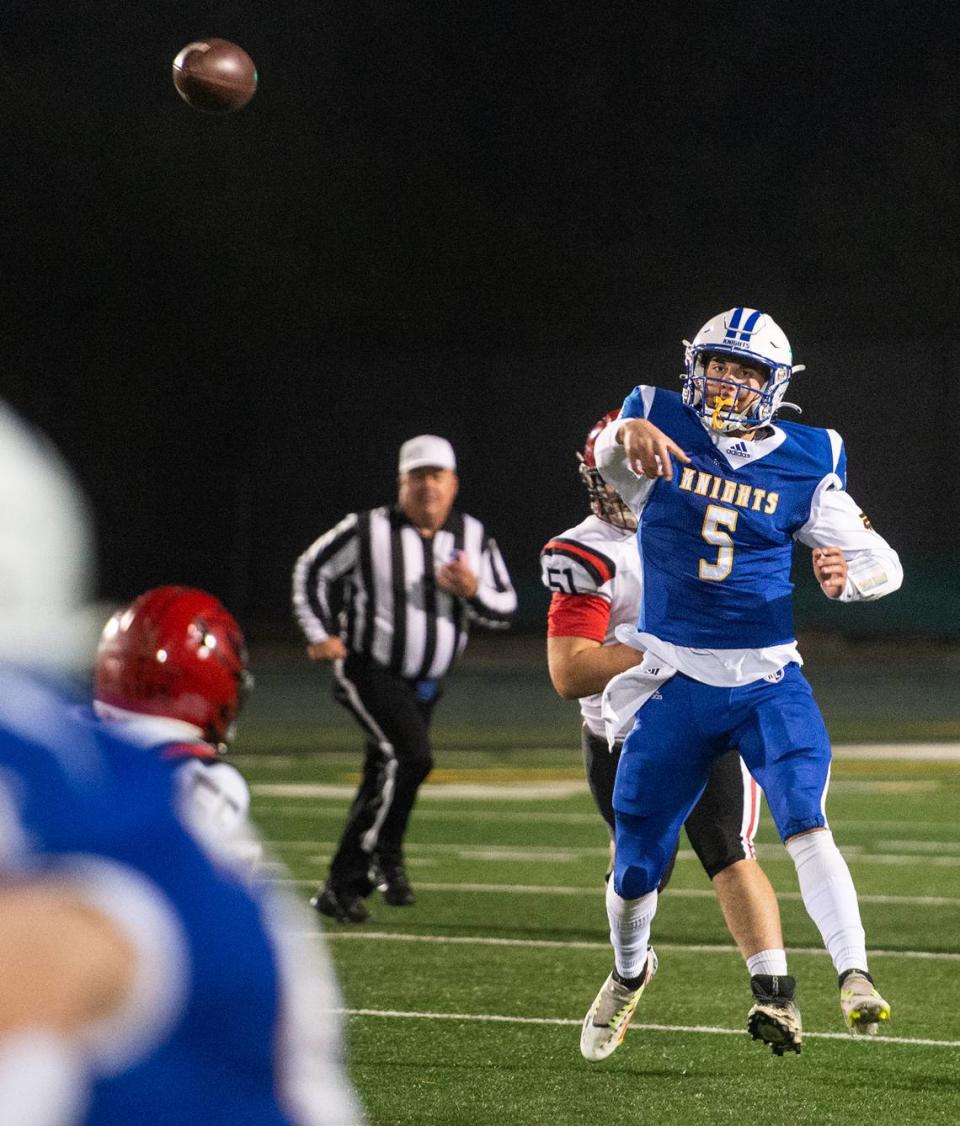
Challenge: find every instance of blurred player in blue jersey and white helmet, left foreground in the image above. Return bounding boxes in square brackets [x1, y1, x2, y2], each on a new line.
[0, 405, 361, 1126]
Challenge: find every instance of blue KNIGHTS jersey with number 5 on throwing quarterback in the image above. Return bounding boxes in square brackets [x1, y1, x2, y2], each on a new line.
[621, 387, 845, 649]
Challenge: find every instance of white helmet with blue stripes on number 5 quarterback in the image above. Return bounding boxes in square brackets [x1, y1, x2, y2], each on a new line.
[682, 305, 804, 432]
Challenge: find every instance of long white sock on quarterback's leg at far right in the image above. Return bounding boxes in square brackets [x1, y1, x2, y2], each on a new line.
[787, 830, 869, 974]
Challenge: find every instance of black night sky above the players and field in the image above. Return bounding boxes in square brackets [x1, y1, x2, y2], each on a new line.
[0, 0, 960, 634]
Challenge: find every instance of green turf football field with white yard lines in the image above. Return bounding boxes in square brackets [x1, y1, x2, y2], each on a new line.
[236, 648, 960, 1126]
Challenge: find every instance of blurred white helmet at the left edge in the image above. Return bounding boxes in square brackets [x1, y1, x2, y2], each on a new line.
[0, 402, 97, 669]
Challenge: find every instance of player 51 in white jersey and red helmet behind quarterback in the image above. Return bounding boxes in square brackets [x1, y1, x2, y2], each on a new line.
[540, 411, 801, 1046]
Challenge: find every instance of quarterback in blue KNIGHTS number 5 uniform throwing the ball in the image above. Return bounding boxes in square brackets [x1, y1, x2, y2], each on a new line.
[581, 306, 903, 1060]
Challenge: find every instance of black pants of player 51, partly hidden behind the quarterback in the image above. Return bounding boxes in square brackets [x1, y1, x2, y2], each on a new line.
[581, 724, 756, 891]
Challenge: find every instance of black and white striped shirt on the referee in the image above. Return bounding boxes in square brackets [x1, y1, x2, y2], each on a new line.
[294, 507, 517, 680]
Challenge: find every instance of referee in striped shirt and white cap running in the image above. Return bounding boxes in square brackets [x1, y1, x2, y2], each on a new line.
[293, 434, 517, 922]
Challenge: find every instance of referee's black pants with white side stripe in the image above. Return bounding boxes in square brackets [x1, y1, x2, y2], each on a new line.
[330, 653, 439, 895]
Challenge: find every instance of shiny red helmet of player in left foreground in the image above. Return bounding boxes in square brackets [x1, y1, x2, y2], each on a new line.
[93, 587, 251, 744]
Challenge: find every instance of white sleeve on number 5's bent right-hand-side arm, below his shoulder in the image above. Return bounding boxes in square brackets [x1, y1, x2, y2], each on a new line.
[796, 486, 904, 602]
